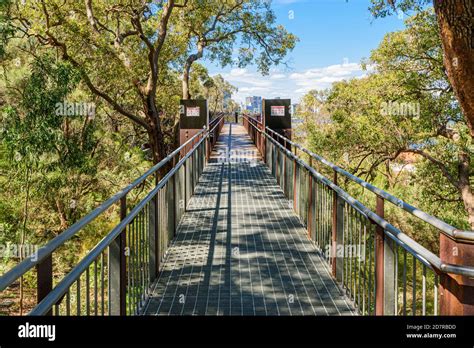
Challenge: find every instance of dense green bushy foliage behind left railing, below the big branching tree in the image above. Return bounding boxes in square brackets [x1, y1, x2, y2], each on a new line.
[0, 49, 154, 313]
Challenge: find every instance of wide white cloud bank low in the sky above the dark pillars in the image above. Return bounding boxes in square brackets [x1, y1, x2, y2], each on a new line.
[215, 62, 373, 103]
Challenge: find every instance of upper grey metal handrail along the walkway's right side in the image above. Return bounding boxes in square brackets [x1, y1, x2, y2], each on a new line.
[262, 124, 474, 241]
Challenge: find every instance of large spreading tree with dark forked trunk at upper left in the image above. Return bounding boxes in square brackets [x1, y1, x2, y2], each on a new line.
[3, 0, 188, 162]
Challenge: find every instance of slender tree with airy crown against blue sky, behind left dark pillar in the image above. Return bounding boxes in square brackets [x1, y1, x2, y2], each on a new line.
[178, 0, 297, 99]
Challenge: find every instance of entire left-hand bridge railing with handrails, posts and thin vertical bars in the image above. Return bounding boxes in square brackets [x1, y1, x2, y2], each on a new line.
[0, 115, 224, 316]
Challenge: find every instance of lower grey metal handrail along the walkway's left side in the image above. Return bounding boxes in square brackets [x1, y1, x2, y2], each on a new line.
[28, 130, 209, 316]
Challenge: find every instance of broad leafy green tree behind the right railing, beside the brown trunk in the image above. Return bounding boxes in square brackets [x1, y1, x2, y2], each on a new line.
[311, 10, 474, 228]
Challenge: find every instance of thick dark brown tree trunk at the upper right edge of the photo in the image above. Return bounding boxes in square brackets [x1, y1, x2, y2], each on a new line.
[434, 0, 474, 137]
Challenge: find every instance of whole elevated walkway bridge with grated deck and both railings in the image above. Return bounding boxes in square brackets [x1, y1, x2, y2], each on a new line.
[0, 116, 474, 316]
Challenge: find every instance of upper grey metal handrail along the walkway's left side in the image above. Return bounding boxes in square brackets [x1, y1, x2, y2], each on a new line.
[0, 116, 222, 291]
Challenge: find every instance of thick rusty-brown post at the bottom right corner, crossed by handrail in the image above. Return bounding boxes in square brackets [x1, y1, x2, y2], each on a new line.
[439, 234, 474, 315]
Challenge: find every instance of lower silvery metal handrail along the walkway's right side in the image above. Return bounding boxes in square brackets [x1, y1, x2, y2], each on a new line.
[243, 115, 474, 277]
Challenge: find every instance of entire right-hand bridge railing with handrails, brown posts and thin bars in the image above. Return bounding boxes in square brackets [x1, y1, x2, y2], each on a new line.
[244, 117, 474, 315]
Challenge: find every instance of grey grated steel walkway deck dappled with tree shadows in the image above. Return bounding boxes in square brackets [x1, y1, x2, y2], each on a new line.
[144, 124, 355, 315]
